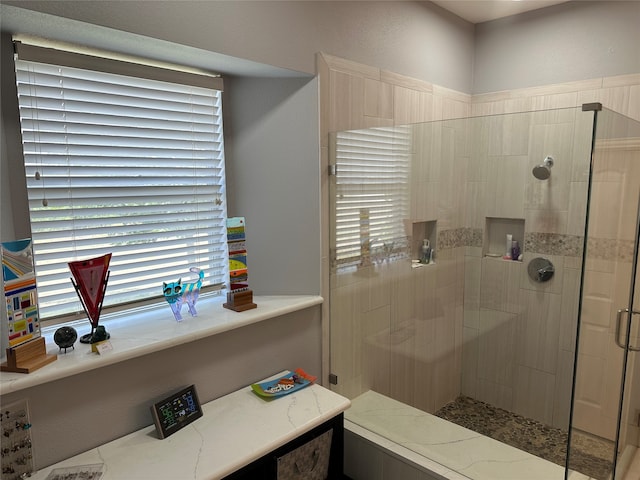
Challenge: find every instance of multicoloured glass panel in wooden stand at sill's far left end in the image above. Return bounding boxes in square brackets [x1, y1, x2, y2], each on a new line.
[0, 238, 58, 373]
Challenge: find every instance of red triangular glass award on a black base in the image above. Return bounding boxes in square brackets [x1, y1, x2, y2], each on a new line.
[69, 253, 111, 343]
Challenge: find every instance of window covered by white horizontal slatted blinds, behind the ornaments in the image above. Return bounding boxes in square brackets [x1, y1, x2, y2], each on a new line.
[16, 40, 228, 320]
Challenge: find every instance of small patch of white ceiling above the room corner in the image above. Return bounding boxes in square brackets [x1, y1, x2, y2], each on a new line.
[432, 0, 567, 23]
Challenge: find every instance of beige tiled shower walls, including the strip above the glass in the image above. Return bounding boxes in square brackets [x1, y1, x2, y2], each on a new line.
[317, 54, 640, 426]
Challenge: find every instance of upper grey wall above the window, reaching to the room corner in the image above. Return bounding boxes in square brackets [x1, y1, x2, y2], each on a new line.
[3, 0, 473, 92]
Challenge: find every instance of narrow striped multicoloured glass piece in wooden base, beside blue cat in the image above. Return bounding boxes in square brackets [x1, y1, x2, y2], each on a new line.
[223, 217, 257, 312]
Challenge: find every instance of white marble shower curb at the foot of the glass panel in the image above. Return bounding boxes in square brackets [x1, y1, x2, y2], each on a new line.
[345, 391, 591, 480]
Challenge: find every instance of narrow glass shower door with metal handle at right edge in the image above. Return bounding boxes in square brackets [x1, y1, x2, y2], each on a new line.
[568, 109, 640, 480]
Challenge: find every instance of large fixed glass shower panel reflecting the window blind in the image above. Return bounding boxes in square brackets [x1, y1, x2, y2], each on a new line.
[329, 108, 640, 480]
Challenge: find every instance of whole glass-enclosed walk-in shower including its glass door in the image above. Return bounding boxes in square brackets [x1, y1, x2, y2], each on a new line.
[329, 104, 640, 480]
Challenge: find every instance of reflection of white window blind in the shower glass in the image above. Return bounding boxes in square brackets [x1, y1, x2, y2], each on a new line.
[334, 126, 411, 266]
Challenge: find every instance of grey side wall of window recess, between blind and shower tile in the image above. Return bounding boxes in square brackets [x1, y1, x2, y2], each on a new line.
[223, 78, 321, 295]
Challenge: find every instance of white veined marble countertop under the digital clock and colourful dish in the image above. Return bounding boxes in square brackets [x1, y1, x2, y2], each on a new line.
[31, 374, 350, 480]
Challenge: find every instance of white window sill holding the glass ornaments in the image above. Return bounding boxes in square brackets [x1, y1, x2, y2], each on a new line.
[0, 295, 323, 395]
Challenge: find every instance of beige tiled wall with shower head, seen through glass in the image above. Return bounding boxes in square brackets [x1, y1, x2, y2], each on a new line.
[461, 108, 593, 428]
